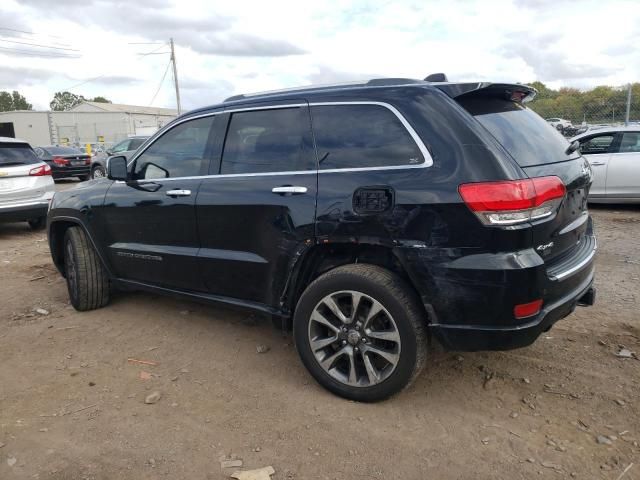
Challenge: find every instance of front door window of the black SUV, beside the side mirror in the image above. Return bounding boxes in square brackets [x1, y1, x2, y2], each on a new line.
[134, 115, 215, 180]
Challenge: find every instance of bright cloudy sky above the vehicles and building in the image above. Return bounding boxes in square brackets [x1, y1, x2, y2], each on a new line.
[0, 0, 640, 110]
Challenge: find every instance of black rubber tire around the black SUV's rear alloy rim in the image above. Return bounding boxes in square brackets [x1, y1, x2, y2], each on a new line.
[293, 264, 427, 402]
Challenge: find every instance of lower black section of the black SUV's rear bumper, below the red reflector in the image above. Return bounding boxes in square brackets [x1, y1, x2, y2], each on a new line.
[430, 272, 595, 351]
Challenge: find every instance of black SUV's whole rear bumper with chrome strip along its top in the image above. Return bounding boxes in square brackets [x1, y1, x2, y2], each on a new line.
[398, 226, 597, 350]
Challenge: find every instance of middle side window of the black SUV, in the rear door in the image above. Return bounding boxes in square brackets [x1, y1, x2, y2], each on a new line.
[220, 107, 315, 175]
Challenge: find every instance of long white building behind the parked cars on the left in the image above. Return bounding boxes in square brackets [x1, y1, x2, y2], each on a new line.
[0, 102, 177, 146]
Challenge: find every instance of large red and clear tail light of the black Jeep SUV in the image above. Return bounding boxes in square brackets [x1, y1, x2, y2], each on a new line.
[458, 176, 566, 225]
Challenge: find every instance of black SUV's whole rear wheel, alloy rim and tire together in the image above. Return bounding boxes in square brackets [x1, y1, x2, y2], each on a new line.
[294, 264, 426, 402]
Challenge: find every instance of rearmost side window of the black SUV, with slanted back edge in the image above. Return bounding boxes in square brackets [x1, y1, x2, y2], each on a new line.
[311, 104, 425, 170]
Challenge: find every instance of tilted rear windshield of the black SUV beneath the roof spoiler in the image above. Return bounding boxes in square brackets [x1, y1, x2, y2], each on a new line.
[458, 97, 579, 167]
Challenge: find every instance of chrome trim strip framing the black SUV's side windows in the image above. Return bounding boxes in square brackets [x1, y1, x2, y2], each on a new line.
[126, 101, 433, 183]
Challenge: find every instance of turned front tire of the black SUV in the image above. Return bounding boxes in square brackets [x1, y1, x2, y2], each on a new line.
[64, 227, 109, 311]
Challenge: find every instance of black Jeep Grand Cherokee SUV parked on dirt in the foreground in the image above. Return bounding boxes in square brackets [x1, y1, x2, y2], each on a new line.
[48, 79, 596, 401]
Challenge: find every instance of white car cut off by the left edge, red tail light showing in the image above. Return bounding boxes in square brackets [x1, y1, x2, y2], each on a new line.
[0, 137, 55, 230]
